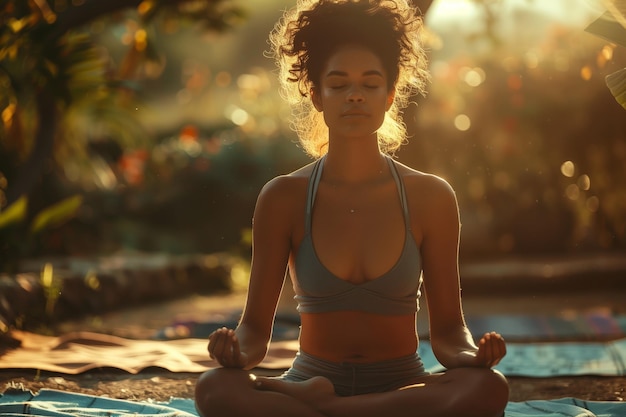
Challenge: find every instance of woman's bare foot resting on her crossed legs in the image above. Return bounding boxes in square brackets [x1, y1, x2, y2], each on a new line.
[255, 376, 336, 408]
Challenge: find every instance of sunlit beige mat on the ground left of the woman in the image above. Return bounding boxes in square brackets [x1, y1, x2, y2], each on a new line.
[0, 331, 298, 375]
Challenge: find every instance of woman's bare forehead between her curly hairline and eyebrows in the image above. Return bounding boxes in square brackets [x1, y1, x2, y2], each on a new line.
[323, 45, 386, 77]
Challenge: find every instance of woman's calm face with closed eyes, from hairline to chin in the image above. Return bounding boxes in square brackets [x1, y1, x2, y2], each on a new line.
[311, 45, 393, 141]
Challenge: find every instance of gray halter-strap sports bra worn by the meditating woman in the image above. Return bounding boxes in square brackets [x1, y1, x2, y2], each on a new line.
[294, 158, 422, 315]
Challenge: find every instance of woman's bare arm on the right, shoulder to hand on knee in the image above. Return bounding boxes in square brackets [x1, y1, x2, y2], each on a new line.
[416, 176, 506, 369]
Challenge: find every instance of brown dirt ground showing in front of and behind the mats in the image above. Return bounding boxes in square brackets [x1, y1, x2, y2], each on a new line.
[0, 291, 626, 401]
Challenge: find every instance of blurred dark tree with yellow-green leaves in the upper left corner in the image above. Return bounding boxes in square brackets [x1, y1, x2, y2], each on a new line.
[0, 0, 244, 270]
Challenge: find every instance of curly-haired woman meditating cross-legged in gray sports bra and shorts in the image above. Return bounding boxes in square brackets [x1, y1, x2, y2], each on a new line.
[196, 0, 508, 417]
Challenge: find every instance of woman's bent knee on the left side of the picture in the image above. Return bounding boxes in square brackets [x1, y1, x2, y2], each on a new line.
[194, 368, 252, 416]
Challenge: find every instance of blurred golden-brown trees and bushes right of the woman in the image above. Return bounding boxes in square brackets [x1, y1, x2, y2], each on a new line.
[401, 7, 626, 257]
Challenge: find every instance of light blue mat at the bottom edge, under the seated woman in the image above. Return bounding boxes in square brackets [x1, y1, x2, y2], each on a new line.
[0, 389, 626, 417]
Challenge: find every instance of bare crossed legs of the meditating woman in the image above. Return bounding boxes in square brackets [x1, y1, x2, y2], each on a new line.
[196, 368, 508, 417]
